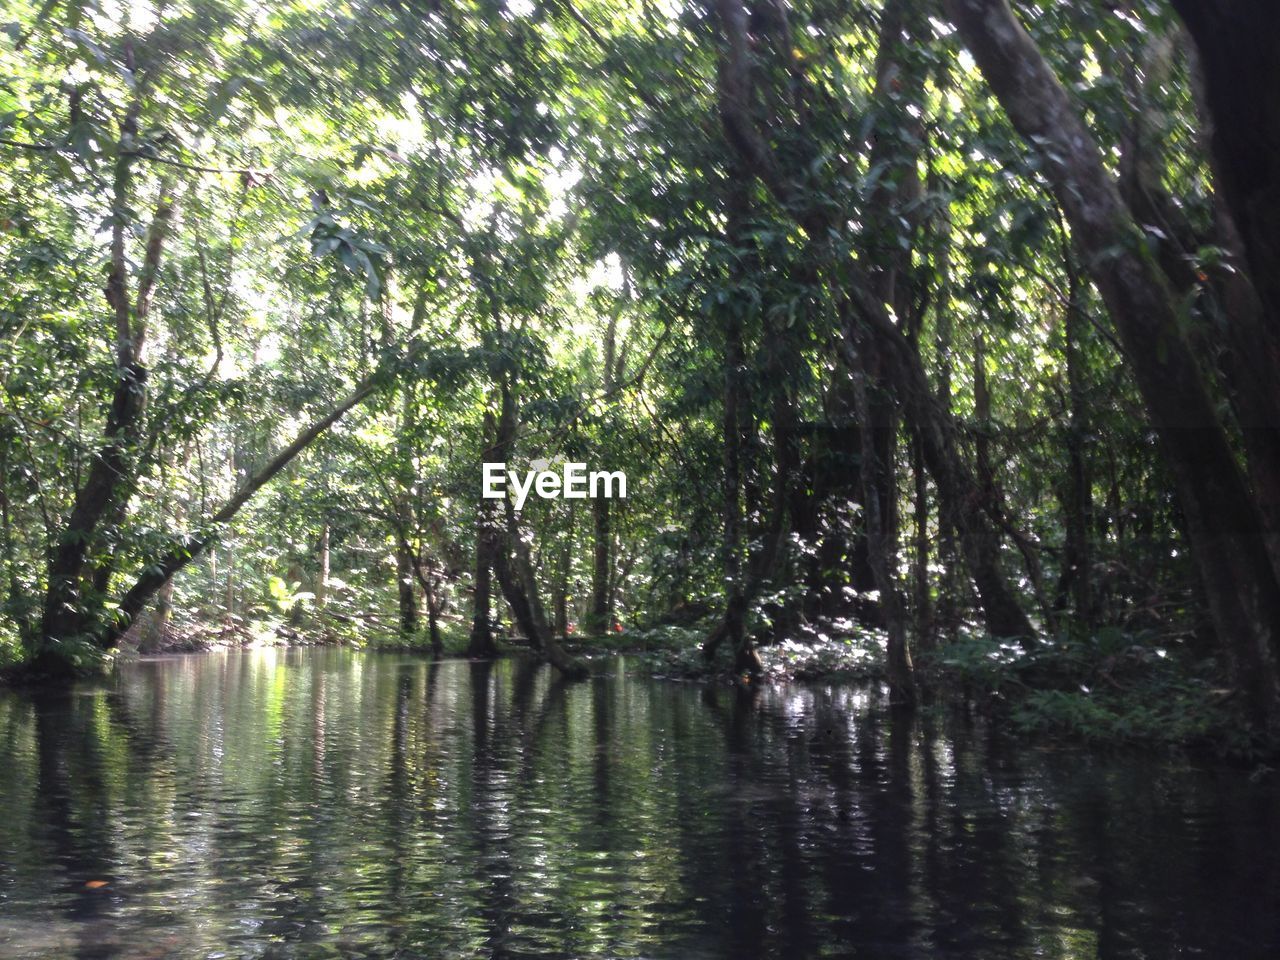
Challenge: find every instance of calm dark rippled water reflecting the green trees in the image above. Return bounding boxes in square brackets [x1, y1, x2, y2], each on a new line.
[0, 650, 1280, 960]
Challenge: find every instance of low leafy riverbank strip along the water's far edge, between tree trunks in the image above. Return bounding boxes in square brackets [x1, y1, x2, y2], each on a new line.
[0, 616, 1264, 772]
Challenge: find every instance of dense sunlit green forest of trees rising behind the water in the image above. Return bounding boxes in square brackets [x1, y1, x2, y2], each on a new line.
[0, 0, 1280, 749]
